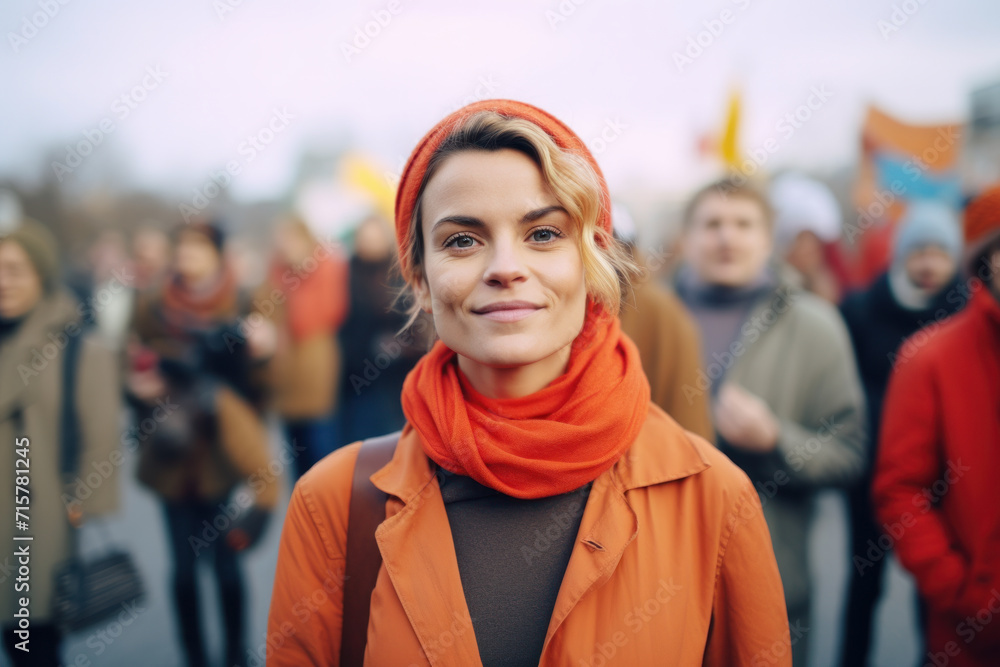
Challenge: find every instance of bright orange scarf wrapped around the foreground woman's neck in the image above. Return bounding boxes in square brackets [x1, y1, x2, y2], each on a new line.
[402, 301, 649, 498]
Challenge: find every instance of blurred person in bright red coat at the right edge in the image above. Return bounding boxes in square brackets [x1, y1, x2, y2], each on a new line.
[866, 185, 1000, 667]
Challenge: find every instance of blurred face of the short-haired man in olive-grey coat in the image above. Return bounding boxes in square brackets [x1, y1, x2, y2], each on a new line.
[683, 193, 773, 287]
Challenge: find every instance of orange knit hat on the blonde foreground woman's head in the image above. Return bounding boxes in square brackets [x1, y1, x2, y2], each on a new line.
[396, 100, 612, 276]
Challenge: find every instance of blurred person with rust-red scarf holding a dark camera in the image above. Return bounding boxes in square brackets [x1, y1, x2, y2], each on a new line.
[126, 221, 279, 667]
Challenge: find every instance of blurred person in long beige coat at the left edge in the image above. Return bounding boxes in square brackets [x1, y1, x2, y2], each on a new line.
[0, 220, 124, 665]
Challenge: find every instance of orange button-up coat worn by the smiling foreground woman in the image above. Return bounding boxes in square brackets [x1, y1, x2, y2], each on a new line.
[266, 403, 791, 667]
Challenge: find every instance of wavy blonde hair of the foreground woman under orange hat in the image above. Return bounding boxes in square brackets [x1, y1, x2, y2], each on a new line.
[401, 111, 639, 328]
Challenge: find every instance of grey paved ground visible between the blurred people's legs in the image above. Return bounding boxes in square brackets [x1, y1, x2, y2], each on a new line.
[0, 438, 917, 667]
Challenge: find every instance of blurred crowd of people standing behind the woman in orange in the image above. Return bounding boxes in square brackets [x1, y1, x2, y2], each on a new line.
[0, 163, 1000, 666]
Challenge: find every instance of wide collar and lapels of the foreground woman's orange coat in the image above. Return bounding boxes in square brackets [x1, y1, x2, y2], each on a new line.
[371, 403, 711, 665]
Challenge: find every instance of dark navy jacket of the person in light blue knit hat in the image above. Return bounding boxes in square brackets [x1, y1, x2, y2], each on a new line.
[840, 273, 968, 461]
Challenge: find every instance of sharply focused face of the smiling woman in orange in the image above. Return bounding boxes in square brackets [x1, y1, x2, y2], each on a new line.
[415, 149, 587, 375]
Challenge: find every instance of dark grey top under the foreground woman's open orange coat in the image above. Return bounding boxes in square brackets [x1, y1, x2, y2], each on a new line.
[437, 468, 591, 667]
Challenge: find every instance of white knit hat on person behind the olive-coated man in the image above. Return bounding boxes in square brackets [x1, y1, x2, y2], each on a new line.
[770, 172, 841, 248]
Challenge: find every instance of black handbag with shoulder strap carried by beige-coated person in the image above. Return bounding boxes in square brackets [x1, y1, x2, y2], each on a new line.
[53, 334, 146, 632]
